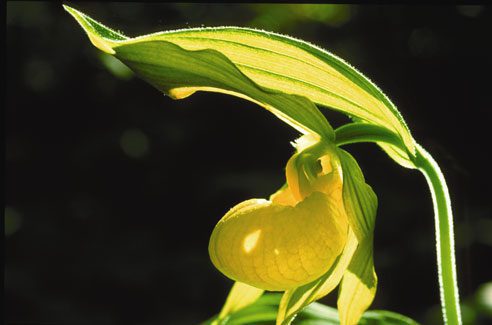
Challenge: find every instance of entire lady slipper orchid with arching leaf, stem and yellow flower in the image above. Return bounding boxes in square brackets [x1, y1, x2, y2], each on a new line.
[64, 6, 462, 325]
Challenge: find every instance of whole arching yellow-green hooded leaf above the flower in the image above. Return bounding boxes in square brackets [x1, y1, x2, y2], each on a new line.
[65, 6, 415, 167]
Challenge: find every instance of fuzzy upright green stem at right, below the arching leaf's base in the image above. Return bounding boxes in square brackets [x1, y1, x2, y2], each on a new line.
[414, 145, 461, 324]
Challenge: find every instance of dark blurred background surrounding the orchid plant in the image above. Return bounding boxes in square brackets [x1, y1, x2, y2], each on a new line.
[4, 2, 492, 324]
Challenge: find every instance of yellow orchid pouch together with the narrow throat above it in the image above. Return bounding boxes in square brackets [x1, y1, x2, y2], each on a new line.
[209, 138, 348, 291]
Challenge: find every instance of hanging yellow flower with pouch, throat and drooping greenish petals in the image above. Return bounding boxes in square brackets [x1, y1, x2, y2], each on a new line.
[209, 135, 376, 324]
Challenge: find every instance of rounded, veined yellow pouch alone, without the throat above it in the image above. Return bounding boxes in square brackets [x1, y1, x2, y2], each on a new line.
[209, 192, 348, 291]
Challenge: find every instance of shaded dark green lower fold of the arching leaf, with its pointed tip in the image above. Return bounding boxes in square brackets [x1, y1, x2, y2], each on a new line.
[66, 7, 334, 141]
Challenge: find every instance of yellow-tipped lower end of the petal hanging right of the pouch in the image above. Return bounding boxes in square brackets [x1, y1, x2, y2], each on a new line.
[337, 238, 378, 325]
